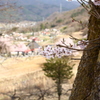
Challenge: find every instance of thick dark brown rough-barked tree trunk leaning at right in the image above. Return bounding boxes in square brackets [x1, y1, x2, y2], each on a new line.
[69, 6, 100, 100]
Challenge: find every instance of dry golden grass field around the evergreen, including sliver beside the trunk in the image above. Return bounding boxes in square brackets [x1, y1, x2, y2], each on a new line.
[0, 57, 79, 92]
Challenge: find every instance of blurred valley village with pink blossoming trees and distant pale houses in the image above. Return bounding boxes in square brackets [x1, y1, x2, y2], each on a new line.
[0, 23, 62, 57]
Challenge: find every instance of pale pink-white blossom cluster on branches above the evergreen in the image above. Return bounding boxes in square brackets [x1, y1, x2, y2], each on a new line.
[38, 38, 87, 59]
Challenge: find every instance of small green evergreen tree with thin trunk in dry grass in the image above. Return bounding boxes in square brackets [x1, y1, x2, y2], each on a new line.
[42, 58, 73, 100]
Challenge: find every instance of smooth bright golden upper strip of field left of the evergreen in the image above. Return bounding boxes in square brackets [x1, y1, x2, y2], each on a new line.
[0, 56, 45, 78]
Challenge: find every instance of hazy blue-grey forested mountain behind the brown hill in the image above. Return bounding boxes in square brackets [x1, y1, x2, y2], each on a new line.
[0, 0, 79, 22]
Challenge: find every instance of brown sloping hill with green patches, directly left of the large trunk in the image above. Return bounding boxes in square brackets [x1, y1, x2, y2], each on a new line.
[34, 7, 89, 33]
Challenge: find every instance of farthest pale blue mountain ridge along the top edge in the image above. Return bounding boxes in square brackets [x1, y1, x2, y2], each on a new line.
[17, 0, 80, 9]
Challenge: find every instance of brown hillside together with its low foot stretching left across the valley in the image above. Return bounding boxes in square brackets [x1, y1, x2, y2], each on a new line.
[1, 7, 89, 34]
